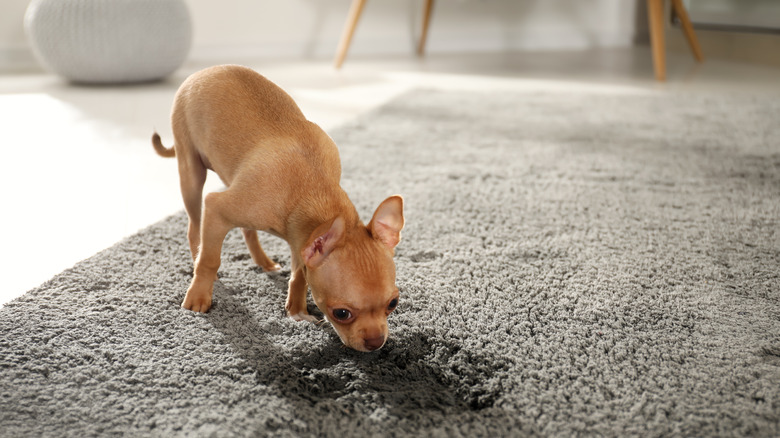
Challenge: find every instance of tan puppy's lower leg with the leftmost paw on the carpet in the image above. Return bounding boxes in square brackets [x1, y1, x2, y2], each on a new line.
[181, 192, 233, 313]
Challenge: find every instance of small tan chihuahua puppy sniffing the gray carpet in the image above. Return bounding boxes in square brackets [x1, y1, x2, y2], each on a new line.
[152, 65, 404, 352]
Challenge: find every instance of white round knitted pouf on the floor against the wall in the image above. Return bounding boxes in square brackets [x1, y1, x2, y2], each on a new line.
[24, 0, 192, 83]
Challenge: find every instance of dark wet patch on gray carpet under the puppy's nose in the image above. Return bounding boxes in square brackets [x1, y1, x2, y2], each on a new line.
[289, 334, 505, 417]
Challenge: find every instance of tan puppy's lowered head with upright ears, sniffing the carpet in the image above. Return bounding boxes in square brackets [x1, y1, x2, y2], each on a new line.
[301, 196, 404, 351]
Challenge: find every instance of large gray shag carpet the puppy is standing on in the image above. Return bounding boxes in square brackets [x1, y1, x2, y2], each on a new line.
[0, 90, 780, 437]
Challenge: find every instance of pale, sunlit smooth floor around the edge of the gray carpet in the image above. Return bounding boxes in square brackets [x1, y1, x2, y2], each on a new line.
[0, 48, 780, 304]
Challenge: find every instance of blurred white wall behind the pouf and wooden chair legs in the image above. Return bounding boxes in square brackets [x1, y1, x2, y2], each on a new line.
[0, 0, 637, 71]
